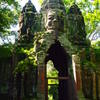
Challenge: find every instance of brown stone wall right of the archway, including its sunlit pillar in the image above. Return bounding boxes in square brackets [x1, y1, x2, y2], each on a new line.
[72, 49, 100, 100]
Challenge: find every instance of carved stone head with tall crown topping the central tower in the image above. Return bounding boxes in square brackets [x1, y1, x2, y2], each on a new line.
[41, 0, 65, 32]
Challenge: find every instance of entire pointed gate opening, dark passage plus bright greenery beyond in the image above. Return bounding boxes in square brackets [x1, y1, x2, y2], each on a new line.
[45, 41, 70, 100]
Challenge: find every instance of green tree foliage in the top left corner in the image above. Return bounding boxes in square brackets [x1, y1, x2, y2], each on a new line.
[0, 0, 20, 35]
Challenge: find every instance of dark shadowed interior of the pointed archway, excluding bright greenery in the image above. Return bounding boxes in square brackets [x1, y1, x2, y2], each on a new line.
[45, 41, 70, 100]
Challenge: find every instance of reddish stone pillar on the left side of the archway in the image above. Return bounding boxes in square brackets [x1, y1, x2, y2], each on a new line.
[37, 66, 45, 100]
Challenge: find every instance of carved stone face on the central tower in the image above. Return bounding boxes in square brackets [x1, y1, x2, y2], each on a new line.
[45, 11, 59, 31]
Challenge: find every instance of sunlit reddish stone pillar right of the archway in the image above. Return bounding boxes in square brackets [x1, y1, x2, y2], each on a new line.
[72, 54, 82, 90]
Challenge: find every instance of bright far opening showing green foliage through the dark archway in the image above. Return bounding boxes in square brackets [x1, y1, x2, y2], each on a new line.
[46, 60, 59, 100]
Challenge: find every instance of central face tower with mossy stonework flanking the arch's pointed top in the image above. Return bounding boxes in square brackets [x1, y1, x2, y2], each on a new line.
[35, 0, 76, 65]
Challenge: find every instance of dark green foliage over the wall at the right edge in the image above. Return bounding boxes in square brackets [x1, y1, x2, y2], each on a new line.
[81, 41, 100, 71]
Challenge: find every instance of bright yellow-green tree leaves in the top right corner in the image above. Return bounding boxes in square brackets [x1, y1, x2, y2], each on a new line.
[76, 0, 100, 34]
